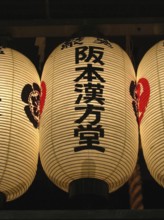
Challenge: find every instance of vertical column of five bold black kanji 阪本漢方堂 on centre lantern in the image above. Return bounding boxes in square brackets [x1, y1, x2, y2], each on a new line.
[74, 41, 105, 152]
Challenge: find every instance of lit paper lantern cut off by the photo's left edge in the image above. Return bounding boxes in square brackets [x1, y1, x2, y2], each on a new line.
[0, 48, 40, 201]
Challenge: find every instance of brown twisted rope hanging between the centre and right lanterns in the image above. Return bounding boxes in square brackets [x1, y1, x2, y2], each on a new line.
[126, 35, 144, 210]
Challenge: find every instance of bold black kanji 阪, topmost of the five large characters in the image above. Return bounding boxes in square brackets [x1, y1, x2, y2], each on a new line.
[75, 46, 104, 65]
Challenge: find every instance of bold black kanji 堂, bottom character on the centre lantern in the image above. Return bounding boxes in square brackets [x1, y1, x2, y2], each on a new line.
[74, 125, 105, 152]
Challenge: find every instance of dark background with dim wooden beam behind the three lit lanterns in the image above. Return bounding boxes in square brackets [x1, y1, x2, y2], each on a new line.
[0, 0, 164, 210]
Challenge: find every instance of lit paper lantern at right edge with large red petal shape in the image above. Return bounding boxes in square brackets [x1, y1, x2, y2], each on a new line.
[137, 41, 164, 187]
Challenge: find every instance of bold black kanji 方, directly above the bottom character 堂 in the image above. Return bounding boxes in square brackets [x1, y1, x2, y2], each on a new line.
[75, 104, 104, 125]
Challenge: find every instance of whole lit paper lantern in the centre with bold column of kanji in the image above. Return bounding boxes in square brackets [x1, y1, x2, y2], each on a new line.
[40, 37, 138, 197]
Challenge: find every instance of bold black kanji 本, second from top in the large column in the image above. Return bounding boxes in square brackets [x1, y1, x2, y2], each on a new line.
[74, 64, 105, 82]
